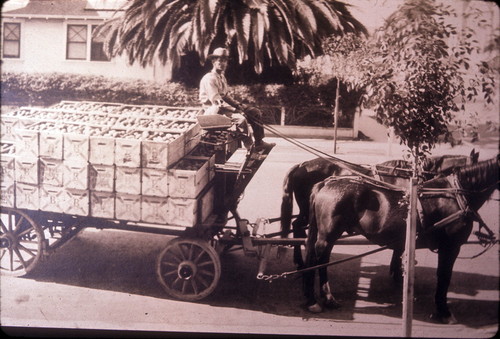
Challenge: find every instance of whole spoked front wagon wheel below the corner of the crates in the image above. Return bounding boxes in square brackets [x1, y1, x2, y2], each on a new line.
[156, 238, 221, 301]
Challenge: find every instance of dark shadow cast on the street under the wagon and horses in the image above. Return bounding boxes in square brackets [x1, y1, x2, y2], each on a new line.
[26, 231, 499, 328]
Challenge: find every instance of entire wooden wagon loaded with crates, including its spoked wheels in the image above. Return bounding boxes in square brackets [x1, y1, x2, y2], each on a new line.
[0, 101, 286, 300]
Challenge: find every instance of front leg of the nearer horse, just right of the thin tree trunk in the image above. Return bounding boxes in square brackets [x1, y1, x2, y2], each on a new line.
[431, 245, 460, 324]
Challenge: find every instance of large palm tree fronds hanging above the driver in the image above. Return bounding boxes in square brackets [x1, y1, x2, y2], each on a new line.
[102, 0, 367, 83]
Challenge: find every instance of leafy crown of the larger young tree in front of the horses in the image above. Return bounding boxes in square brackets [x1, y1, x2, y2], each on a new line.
[365, 0, 495, 163]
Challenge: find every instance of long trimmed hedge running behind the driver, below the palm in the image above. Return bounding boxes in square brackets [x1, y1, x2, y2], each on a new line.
[1, 72, 359, 127]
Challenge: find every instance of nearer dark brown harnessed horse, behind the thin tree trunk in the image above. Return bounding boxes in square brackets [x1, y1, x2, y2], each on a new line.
[304, 156, 500, 323]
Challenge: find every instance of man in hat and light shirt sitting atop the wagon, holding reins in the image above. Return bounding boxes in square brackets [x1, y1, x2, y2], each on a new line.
[200, 47, 274, 150]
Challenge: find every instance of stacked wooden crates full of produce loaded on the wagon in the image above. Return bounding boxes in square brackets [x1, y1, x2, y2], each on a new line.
[1, 101, 215, 227]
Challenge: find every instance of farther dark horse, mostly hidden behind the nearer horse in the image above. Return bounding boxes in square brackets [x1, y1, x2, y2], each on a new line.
[281, 149, 479, 270]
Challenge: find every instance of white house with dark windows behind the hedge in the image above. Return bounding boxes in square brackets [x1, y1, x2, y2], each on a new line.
[1, 0, 167, 82]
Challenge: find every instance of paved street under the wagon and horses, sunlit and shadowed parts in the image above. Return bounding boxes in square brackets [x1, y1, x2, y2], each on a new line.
[0, 138, 499, 338]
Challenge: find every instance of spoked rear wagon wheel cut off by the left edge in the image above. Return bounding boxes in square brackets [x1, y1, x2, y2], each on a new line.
[0, 207, 45, 276]
